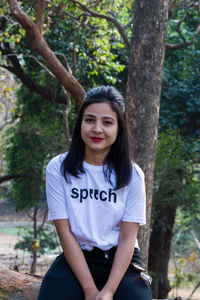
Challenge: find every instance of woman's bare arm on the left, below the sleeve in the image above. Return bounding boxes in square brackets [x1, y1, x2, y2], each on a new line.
[54, 219, 98, 300]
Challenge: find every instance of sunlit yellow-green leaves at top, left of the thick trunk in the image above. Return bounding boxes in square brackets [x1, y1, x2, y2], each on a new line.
[0, 0, 133, 89]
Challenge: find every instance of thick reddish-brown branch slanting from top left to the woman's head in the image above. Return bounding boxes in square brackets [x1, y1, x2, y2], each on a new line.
[8, 0, 85, 105]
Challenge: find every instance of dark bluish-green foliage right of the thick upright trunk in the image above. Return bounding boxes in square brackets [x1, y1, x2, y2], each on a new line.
[160, 51, 200, 139]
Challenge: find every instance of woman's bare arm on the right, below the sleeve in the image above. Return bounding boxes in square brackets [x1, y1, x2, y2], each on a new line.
[94, 222, 139, 300]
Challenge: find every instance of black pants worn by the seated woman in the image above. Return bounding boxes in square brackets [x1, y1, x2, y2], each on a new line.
[38, 248, 152, 300]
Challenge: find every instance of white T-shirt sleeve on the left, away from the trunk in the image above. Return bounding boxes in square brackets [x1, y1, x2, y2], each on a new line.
[46, 156, 68, 220]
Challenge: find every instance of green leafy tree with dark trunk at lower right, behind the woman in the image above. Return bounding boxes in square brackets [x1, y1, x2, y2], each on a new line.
[149, 129, 200, 299]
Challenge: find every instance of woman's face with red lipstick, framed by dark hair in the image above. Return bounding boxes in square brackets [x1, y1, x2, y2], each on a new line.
[81, 103, 118, 159]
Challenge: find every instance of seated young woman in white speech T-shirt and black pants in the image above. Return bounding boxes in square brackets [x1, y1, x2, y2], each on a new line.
[38, 86, 152, 300]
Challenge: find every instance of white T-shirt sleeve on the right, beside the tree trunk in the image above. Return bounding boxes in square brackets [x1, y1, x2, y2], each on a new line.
[122, 163, 146, 225]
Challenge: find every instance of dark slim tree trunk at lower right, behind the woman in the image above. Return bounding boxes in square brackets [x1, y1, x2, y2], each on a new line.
[149, 203, 177, 299]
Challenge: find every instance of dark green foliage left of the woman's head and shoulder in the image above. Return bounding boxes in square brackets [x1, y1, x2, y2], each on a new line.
[4, 87, 66, 210]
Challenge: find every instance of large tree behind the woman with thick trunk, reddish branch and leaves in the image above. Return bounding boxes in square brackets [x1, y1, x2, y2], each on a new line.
[1, 0, 198, 266]
